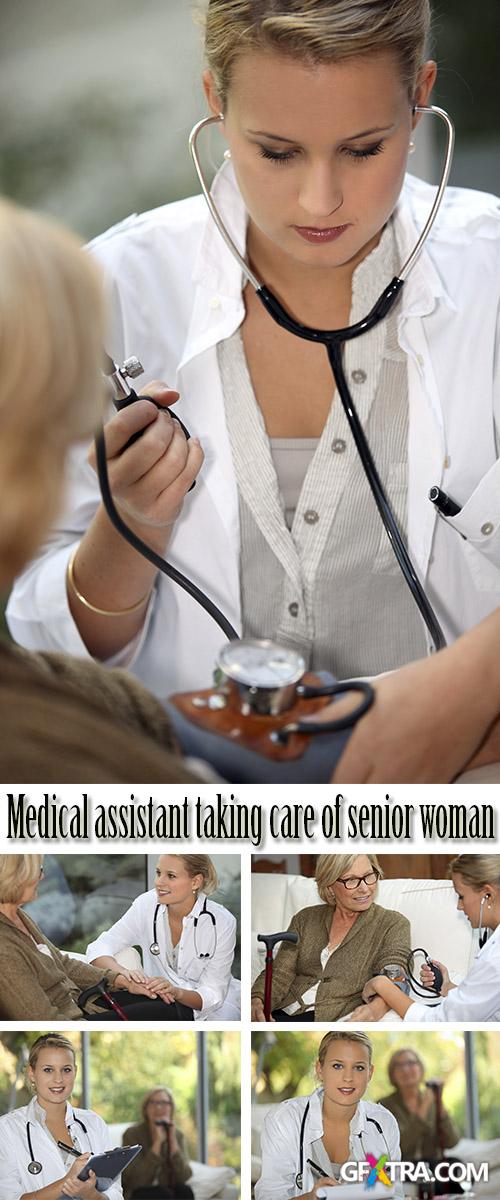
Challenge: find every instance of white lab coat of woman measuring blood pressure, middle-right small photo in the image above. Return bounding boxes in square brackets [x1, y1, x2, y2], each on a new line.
[404, 925, 500, 1024]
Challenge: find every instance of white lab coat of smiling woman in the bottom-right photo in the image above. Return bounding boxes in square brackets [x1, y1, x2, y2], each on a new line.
[255, 1087, 404, 1200]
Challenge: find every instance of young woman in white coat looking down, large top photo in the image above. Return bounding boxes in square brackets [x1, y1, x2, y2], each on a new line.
[4, 0, 500, 720]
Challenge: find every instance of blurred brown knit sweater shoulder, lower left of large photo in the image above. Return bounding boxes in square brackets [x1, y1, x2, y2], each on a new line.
[0, 638, 199, 785]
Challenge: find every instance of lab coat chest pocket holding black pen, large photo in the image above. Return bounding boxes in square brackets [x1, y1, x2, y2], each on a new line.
[446, 460, 500, 592]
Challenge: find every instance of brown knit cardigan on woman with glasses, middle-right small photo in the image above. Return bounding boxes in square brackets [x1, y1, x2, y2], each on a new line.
[252, 904, 410, 1021]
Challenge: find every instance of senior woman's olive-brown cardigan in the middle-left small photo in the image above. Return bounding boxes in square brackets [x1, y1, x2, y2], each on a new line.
[0, 911, 116, 1021]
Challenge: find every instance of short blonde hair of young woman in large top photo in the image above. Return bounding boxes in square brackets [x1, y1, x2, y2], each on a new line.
[204, 0, 430, 106]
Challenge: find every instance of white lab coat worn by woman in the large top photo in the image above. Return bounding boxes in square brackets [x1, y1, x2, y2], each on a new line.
[7, 166, 500, 698]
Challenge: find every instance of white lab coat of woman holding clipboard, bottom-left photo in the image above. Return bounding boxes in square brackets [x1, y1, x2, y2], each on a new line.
[0, 1099, 124, 1200]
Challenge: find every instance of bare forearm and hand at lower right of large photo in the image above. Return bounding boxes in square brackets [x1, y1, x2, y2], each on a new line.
[330, 608, 500, 784]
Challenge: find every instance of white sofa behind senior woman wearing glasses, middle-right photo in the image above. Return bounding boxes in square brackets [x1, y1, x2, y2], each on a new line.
[252, 874, 477, 1020]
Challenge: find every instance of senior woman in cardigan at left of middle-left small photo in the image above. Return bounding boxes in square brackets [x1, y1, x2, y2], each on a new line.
[0, 854, 191, 1021]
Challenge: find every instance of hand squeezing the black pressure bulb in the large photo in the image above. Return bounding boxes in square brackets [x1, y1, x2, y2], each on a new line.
[89, 379, 204, 529]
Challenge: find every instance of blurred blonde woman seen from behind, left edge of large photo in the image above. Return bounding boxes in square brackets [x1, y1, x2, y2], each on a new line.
[0, 200, 205, 785]
